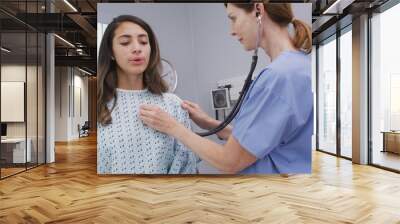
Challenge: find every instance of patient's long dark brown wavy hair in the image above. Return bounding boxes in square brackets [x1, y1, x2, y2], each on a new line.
[97, 15, 168, 125]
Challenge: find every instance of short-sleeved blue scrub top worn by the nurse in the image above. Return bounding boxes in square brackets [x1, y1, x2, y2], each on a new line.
[232, 51, 314, 174]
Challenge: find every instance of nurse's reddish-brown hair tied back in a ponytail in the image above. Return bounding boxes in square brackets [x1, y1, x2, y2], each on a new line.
[225, 0, 312, 54]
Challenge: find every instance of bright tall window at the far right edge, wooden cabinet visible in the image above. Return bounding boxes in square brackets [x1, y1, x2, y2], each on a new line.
[370, 1, 400, 170]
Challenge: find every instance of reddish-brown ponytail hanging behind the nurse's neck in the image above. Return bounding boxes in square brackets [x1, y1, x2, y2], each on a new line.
[292, 19, 312, 54]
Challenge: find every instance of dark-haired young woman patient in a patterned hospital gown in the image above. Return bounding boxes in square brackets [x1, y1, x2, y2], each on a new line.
[97, 15, 197, 174]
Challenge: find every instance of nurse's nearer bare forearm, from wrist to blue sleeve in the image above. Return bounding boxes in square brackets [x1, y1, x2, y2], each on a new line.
[173, 125, 257, 173]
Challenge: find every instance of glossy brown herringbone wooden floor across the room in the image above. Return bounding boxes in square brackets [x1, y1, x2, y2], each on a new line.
[0, 134, 400, 224]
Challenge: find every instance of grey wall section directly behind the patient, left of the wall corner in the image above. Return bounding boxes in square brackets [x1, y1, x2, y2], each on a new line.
[97, 3, 198, 104]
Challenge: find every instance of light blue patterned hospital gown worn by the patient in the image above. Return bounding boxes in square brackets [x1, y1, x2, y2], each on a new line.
[97, 89, 198, 174]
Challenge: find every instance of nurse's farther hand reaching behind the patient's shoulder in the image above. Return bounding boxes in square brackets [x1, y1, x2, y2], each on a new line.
[181, 100, 214, 129]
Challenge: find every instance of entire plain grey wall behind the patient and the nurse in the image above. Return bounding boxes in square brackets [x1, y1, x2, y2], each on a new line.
[97, 3, 311, 173]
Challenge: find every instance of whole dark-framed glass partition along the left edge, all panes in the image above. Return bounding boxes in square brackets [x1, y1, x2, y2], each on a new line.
[0, 1, 46, 179]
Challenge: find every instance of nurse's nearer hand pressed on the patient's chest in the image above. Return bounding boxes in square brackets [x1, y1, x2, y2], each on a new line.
[139, 104, 182, 136]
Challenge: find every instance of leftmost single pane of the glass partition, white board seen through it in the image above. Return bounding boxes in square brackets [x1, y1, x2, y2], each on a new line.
[0, 32, 27, 177]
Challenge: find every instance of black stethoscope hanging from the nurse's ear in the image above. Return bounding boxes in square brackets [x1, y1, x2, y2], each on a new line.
[197, 11, 262, 137]
